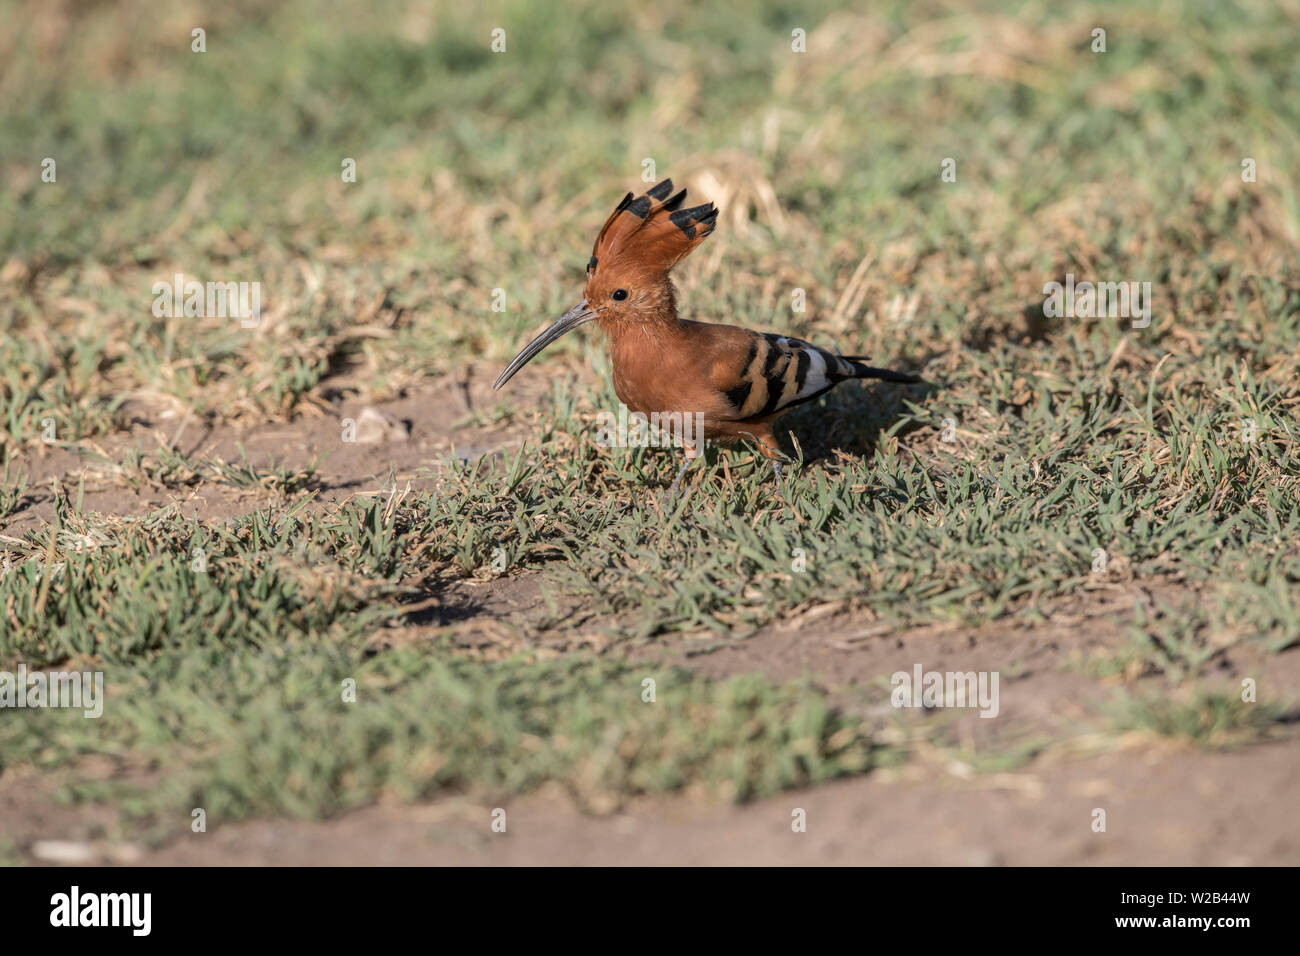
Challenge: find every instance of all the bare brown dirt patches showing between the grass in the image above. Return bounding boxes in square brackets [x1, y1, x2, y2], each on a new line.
[0, 375, 1300, 865]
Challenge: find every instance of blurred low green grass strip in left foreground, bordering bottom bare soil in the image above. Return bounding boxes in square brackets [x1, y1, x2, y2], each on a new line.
[0, 641, 888, 836]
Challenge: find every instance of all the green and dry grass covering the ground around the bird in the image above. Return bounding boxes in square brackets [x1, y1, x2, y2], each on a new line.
[0, 0, 1300, 831]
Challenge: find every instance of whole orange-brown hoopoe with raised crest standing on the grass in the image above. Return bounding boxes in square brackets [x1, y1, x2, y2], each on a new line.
[494, 179, 920, 494]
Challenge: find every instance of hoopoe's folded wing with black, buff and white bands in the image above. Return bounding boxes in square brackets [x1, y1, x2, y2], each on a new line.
[714, 332, 853, 421]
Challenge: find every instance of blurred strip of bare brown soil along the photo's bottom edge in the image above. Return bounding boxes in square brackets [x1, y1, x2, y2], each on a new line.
[12, 740, 1300, 866]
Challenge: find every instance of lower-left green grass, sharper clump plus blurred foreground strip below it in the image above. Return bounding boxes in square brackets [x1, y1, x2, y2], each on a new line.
[0, 489, 885, 826]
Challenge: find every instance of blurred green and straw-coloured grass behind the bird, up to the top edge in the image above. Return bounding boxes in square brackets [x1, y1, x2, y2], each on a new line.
[0, 1, 1300, 441]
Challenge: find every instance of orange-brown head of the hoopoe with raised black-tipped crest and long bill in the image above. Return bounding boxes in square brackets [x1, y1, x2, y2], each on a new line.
[494, 179, 718, 389]
